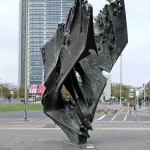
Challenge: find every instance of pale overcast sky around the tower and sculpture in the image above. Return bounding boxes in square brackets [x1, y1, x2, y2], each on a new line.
[0, 0, 150, 86]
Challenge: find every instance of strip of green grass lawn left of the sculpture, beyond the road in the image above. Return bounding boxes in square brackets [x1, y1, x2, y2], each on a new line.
[0, 103, 43, 112]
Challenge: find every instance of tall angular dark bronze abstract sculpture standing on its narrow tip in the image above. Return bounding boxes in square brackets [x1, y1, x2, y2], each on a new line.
[41, 0, 127, 144]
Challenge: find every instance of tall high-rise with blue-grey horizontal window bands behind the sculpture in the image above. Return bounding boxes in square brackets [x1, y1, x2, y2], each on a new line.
[19, 0, 74, 85]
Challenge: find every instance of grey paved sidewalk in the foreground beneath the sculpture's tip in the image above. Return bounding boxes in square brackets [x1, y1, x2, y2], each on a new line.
[0, 128, 150, 150]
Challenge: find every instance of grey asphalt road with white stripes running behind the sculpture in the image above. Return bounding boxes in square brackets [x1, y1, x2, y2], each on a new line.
[0, 105, 150, 123]
